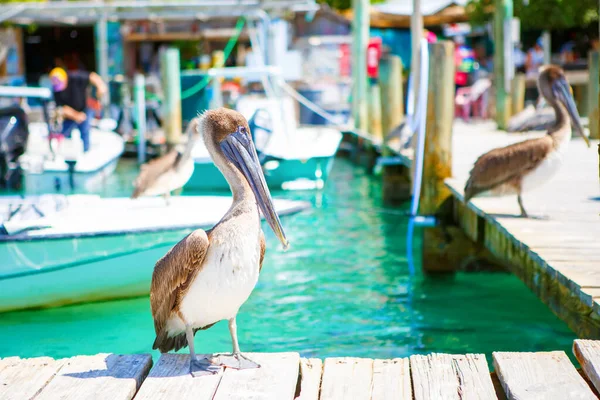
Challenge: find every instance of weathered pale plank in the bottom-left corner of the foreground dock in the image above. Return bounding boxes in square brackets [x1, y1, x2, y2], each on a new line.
[0, 357, 63, 400]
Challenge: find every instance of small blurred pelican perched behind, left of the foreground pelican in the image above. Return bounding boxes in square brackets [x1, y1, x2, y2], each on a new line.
[131, 118, 200, 205]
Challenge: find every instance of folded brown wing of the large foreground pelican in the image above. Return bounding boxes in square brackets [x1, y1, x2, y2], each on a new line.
[150, 229, 210, 352]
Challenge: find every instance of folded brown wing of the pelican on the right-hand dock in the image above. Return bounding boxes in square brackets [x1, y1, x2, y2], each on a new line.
[465, 135, 553, 202]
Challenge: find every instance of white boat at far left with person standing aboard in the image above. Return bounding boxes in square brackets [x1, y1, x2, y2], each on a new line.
[0, 86, 124, 194]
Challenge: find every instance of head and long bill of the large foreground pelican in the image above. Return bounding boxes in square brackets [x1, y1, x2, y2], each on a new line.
[199, 108, 289, 249]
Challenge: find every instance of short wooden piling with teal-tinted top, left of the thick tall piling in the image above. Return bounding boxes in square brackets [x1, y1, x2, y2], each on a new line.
[379, 54, 404, 141]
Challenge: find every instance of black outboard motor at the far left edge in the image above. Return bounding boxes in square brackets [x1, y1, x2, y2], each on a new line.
[0, 106, 29, 190]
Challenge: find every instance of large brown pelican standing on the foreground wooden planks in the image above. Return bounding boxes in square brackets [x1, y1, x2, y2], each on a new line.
[150, 108, 288, 376]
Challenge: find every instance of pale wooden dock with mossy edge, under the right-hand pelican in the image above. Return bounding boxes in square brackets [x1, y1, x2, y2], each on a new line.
[384, 121, 600, 339]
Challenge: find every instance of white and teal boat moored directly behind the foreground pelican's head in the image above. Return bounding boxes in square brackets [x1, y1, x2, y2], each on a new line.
[185, 67, 342, 190]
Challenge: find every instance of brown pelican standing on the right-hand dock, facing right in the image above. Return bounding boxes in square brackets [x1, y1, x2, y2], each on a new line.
[465, 65, 590, 217]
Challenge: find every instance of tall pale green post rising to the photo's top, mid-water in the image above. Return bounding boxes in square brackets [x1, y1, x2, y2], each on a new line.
[352, 0, 370, 132]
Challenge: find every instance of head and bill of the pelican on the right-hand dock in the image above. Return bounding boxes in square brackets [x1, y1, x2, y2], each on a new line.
[538, 65, 590, 147]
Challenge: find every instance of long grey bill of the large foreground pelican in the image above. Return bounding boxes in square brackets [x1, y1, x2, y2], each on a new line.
[221, 129, 289, 249]
